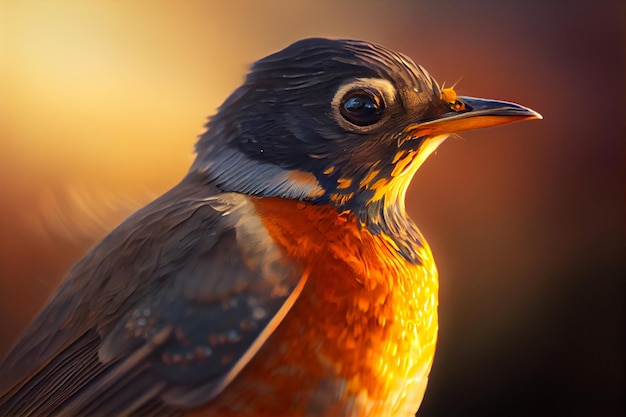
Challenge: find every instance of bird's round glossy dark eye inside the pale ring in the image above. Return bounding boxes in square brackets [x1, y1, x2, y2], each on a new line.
[339, 89, 385, 126]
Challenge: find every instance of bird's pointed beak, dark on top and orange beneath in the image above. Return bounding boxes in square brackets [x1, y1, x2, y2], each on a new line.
[407, 97, 543, 137]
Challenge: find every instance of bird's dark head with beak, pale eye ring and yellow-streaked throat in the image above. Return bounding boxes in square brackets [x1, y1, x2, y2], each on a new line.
[191, 38, 541, 228]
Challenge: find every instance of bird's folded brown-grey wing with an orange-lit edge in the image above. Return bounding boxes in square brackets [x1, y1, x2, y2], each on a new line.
[0, 181, 306, 416]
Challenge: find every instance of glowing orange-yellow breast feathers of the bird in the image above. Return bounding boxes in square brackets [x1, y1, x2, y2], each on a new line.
[190, 198, 437, 416]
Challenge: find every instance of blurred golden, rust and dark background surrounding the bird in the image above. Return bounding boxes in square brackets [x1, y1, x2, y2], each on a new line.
[0, 0, 626, 417]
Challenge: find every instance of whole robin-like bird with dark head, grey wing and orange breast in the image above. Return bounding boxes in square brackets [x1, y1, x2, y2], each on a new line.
[0, 38, 541, 417]
